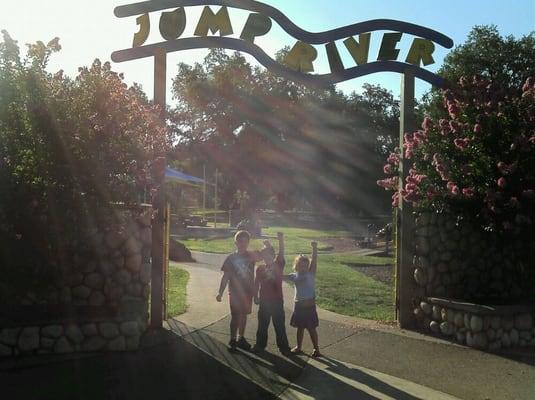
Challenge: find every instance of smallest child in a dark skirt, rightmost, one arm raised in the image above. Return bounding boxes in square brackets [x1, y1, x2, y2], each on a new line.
[286, 242, 321, 357]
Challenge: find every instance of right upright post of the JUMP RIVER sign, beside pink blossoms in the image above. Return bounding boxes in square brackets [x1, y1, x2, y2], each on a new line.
[396, 71, 416, 328]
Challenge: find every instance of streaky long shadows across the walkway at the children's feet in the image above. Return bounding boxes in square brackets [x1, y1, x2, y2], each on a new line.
[168, 320, 430, 400]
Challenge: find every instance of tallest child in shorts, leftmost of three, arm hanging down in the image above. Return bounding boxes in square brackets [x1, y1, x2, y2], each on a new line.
[216, 231, 257, 351]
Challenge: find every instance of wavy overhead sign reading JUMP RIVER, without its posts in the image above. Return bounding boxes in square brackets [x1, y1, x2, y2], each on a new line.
[111, 0, 453, 87]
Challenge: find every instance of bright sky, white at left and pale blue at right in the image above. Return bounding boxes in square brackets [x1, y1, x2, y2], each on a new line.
[0, 0, 535, 102]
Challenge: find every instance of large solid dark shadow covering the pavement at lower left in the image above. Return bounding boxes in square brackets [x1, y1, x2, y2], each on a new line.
[0, 331, 274, 400]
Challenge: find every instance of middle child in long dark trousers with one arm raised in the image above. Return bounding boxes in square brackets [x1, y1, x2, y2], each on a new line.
[253, 232, 290, 355]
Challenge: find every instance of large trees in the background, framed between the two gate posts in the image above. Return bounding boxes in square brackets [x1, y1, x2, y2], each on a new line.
[171, 50, 399, 216]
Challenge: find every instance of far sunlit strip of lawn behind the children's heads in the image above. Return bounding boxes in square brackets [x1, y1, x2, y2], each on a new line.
[181, 227, 351, 254]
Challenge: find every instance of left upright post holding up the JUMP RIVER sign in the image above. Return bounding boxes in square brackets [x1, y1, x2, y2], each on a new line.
[150, 49, 167, 329]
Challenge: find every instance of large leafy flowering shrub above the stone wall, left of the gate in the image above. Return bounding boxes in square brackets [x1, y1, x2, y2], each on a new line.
[0, 31, 167, 294]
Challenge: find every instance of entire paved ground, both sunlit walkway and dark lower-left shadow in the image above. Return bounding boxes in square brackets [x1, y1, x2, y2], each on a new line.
[0, 255, 535, 400]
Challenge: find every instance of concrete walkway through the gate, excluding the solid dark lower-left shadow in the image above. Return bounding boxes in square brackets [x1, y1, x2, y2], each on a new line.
[169, 253, 535, 400]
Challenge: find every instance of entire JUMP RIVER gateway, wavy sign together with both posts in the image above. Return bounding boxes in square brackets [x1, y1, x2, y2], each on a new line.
[111, 0, 453, 328]
